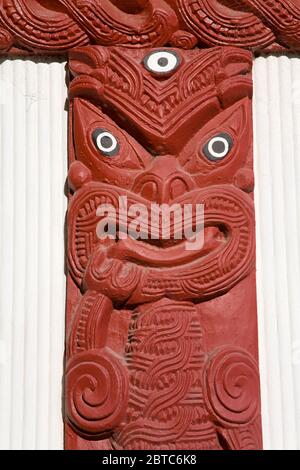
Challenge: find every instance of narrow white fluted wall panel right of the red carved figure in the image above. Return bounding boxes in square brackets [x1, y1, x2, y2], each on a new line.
[254, 56, 300, 449]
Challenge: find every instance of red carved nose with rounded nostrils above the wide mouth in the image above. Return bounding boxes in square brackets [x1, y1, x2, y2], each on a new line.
[133, 155, 194, 204]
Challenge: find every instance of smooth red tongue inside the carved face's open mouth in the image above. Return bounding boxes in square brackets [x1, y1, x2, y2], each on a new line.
[108, 227, 221, 267]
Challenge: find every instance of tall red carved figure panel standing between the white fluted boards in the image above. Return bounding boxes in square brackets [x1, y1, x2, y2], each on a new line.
[66, 46, 261, 449]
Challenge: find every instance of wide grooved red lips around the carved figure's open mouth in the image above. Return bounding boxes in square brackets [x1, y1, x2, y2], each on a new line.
[69, 183, 255, 304]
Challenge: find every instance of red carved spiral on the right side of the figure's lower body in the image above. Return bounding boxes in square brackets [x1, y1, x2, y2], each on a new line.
[204, 347, 259, 427]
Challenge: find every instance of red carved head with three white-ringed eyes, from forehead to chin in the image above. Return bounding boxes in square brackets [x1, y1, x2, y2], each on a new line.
[69, 47, 255, 305]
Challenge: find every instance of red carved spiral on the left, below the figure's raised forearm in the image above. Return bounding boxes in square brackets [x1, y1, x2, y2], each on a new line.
[66, 349, 128, 439]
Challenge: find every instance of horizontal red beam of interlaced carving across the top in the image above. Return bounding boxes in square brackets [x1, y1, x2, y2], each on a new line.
[0, 0, 300, 54]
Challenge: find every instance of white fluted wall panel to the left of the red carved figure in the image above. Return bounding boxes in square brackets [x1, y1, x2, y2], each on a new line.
[0, 60, 67, 449]
